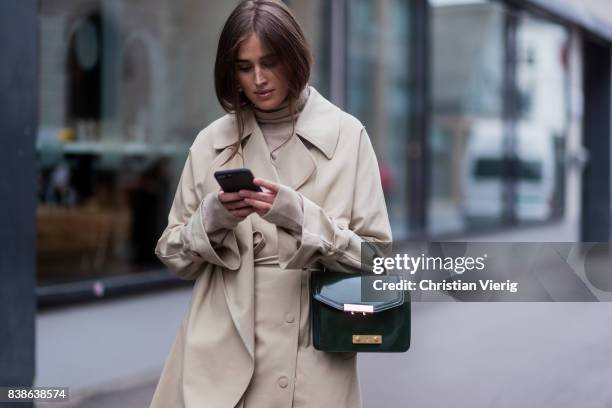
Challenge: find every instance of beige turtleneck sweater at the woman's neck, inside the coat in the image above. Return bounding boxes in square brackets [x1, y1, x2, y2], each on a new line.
[253, 86, 310, 159]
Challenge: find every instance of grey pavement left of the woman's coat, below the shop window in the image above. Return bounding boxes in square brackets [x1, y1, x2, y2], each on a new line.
[35, 288, 191, 408]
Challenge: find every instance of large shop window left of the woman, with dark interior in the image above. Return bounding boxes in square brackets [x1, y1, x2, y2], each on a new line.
[37, 0, 243, 285]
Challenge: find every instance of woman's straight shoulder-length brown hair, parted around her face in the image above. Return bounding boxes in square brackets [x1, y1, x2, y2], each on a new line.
[215, 0, 312, 160]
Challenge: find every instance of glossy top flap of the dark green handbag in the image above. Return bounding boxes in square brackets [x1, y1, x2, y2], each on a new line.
[312, 271, 405, 313]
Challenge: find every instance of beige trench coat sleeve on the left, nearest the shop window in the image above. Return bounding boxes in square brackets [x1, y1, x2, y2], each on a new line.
[155, 150, 240, 280]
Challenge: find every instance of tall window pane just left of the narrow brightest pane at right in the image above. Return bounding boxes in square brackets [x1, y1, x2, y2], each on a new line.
[427, 0, 506, 235]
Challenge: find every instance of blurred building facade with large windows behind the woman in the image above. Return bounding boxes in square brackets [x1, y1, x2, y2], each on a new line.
[29, 0, 612, 297]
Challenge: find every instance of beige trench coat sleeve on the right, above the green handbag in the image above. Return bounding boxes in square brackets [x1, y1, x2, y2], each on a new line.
[263, 129, 391, 272]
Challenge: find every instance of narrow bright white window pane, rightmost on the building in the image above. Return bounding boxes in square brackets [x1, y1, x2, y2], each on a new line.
[514, 15, 570, 223]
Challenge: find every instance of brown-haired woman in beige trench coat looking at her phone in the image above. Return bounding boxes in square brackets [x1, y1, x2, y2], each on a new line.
[151, 0, 391, 408]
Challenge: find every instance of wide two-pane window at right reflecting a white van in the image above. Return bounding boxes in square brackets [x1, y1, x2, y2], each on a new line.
[428, 0, 569, 235]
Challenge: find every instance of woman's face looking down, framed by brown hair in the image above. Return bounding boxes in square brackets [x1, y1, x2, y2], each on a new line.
[236, 34, 288, 110]
